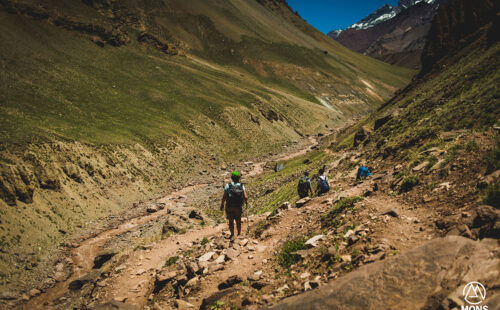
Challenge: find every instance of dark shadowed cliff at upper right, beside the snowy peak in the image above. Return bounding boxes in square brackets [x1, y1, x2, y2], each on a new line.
[421, 0, 500, 74]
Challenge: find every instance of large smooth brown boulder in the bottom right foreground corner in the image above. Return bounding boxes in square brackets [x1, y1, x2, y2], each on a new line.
[270, 236, 500, 309]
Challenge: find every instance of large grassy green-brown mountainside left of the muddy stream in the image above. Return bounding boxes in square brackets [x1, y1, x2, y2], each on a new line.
[0, 0, 414, 300]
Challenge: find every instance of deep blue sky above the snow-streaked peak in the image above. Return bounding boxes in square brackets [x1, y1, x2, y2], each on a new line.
[287, 0, 398, 33]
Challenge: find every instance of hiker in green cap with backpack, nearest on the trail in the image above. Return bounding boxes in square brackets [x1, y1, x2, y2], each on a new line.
[220, 171, 248, 239]
